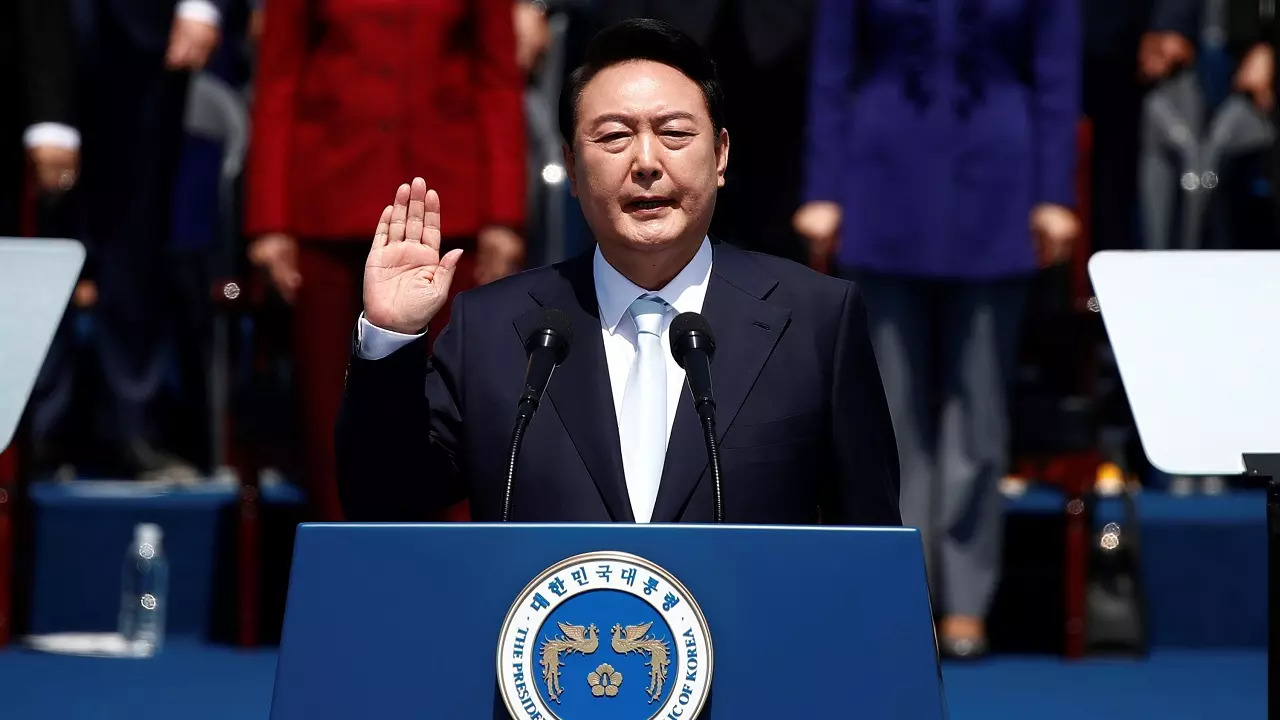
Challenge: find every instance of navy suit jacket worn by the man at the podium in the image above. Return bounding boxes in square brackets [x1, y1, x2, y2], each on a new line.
[337, 242, 901, 525]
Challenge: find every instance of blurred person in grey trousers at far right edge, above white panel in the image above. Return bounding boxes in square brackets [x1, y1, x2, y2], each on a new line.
[1139, 0, 1276, 249]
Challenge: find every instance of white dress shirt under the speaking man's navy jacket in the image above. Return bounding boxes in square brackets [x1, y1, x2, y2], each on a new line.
[356, 238, 712, 515]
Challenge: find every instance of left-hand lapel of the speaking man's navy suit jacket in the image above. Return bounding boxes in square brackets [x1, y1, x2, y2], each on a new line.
[516, 252, 635, 523]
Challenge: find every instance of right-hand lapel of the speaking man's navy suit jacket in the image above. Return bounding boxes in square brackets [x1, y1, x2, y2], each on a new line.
[650, 243, 791, 523]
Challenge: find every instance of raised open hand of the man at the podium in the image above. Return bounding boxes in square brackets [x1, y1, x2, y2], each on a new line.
[365, 178, 462, 334]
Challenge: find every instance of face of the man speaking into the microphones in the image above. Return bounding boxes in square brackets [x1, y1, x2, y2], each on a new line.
[564, 60, 728, 251]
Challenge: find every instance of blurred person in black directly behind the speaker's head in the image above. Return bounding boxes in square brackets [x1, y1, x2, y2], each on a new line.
[578, 0, 813, 263]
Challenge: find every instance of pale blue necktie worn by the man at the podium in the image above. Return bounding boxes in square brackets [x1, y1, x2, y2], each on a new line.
[618, 295, 668, 523]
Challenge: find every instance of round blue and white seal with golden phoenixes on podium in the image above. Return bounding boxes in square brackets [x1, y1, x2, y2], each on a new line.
[498, 551, 713, 720]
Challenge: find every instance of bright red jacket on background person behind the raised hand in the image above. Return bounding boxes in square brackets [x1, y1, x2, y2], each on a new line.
[246, 0, 526, 240]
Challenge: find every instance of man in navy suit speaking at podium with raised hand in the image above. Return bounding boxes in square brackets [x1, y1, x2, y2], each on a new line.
[337, 20, 901, 525]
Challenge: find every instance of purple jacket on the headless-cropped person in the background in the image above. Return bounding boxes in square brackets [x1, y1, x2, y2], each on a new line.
[804, 0, 1082, 279]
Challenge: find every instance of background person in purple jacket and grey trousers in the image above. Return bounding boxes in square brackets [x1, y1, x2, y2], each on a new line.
[795, 0, 1082, 657]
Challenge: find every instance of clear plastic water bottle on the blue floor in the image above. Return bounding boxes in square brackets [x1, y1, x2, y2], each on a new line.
[119, 523, 169, 657]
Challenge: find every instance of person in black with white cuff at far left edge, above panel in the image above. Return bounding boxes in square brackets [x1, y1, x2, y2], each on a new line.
[0, 0, 81, 236]
